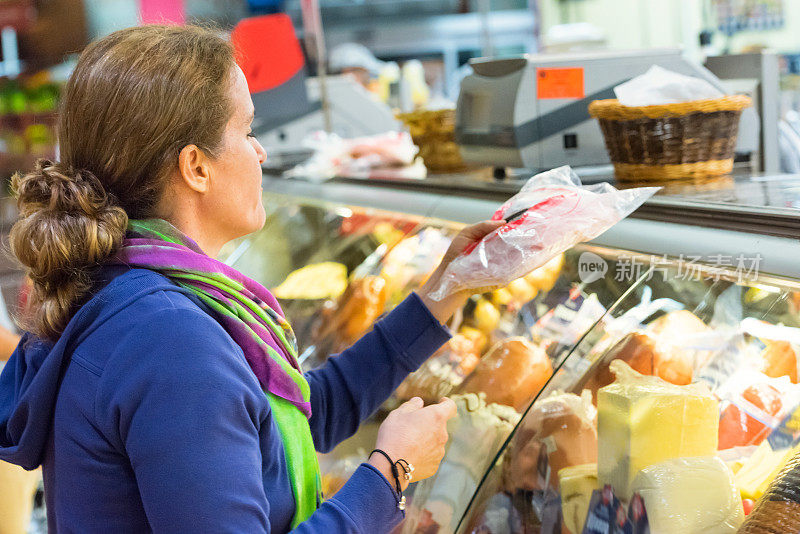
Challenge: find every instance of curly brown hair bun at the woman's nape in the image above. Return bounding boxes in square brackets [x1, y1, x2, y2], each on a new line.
[10, 159, 128, 338]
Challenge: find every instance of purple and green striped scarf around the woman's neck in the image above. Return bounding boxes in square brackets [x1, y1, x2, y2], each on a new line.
[116, 219, 321, 528]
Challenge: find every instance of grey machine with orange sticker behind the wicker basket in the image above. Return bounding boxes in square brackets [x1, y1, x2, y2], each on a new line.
[455, 49, 760, 170]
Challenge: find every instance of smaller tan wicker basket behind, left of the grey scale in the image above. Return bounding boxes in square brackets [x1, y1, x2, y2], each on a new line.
[397, 109, 467, 173]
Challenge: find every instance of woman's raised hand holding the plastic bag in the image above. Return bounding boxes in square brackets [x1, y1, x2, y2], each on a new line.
[417, 221, 505, 324]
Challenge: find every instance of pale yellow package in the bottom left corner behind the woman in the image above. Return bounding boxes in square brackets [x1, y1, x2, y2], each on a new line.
[0, 461, 41, 534]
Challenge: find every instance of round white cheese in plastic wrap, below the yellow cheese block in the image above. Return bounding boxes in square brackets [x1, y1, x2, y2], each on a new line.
[631, 456, 744, 534]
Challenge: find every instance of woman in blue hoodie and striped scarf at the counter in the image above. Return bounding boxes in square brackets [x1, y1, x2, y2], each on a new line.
[0, 26, 499, 533]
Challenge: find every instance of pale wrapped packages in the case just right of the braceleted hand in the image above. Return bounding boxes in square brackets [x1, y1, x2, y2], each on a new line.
[402, 394, 519, 534]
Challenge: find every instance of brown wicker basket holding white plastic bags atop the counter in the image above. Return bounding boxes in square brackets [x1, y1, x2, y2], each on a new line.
[589, 95, 752, 184]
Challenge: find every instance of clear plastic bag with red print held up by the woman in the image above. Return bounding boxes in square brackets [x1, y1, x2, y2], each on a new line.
[424, 166, 658, 300]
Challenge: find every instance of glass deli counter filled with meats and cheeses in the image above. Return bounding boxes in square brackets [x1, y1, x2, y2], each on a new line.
[223, 177, 800, 534]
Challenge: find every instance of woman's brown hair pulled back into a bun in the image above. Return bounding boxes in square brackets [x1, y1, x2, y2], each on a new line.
[10, 25, 235, 339]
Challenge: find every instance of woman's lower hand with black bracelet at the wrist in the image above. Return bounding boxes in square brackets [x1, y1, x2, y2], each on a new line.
[369, 397, 456, 489]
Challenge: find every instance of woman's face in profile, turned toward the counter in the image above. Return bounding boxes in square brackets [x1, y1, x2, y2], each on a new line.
[204, 66, 267, 246]
